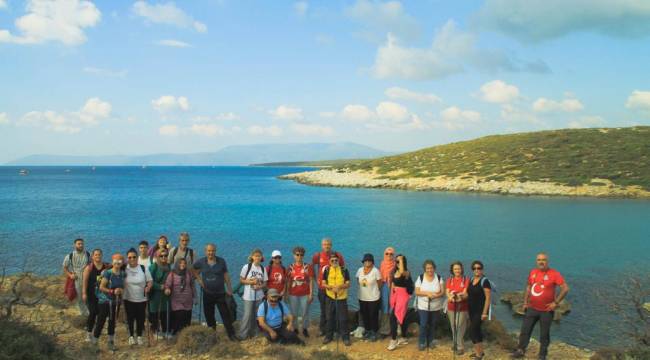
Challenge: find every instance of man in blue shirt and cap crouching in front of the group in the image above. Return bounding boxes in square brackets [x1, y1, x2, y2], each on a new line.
[257, 288, 305, 345]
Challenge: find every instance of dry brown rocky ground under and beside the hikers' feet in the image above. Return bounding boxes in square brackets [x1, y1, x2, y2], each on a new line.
[6, 277, 592, 360]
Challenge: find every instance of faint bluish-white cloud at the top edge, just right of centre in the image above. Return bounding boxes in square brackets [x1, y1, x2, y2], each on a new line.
[345, 0, 420, 42]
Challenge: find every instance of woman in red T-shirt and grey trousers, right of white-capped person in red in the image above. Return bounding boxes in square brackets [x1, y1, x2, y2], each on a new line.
[286, 246, 314, 338]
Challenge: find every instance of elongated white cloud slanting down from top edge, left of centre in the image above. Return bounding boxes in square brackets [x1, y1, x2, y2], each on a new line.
[133, 1, 208, 33]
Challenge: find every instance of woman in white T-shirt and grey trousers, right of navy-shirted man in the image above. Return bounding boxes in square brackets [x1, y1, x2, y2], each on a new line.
[239, 249, 269, 340]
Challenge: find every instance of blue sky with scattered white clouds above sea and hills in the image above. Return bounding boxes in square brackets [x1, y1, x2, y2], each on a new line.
[0, 0, 650, 163]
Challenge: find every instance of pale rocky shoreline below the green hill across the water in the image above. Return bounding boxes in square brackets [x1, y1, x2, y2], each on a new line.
[278, 169, 650, 199]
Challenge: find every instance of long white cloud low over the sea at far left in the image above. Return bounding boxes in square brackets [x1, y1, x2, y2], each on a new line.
[18, 98, 112, 134]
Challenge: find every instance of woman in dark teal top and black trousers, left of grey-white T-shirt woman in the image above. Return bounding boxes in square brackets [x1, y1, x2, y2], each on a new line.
[93, 253, 125, 351]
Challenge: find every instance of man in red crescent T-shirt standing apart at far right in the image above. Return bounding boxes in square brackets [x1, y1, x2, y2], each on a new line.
[512, 253, 569, 360]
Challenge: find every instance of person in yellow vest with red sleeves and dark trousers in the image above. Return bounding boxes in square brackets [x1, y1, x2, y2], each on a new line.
[323, 253, 351, 346]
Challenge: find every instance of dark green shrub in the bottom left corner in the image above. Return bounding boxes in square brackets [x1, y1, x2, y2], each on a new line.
[0, 319, 66, 360]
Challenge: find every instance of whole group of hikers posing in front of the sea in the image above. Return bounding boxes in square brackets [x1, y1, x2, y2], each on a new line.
[63, 233, 569, 359]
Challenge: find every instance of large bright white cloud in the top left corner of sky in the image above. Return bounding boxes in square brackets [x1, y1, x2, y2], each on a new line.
[0, 0, 101, 46]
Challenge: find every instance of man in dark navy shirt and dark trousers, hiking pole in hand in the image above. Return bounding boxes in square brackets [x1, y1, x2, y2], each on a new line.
[192, 244, 237, 341]
